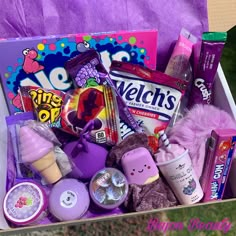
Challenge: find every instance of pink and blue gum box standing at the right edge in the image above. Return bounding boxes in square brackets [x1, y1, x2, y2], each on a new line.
[200, 129, 236, 202]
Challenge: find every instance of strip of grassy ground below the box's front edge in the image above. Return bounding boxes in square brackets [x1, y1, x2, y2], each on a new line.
[7, 201, 236, 236]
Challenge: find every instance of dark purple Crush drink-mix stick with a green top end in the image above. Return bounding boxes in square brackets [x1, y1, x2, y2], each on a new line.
[189, 32, 227, 107]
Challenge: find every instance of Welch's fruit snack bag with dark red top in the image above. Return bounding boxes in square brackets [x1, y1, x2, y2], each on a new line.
[110, 61, 186, 152]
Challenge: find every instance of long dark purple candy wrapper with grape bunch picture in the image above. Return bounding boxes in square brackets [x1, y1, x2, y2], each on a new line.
[65, 49, 141, 139]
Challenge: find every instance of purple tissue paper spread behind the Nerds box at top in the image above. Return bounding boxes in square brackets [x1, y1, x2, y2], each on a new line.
[0, 0, 208, 71]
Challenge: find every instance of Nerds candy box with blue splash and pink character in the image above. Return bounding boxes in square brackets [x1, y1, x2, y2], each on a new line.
[0, 30, 158, 114]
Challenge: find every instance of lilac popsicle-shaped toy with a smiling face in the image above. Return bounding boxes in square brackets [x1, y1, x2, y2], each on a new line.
[121, 147, 159, 185]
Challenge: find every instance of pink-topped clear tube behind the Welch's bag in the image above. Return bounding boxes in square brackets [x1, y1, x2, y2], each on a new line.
[165, 28, 197, 127]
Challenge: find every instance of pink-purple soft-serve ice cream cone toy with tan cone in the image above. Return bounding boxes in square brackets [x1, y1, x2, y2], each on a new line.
[19, 126, 62, 184]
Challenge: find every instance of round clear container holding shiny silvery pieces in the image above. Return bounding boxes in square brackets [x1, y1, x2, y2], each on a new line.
[89, 168, 128, 210]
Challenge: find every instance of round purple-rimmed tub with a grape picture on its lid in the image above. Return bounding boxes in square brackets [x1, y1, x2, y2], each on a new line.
[3, 182, 47, 225]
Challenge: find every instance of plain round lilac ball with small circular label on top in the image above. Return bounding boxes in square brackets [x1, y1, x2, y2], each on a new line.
[49, 179, 90, 221]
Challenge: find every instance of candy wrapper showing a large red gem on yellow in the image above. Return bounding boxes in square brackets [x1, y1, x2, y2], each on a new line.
[61, 85, 120, 145]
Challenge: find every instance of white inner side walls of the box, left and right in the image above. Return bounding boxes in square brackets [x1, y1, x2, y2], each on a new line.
[0, 66, 236, 229]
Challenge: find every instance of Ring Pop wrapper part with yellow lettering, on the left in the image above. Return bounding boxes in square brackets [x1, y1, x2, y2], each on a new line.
[19, 86, 65, 128]
